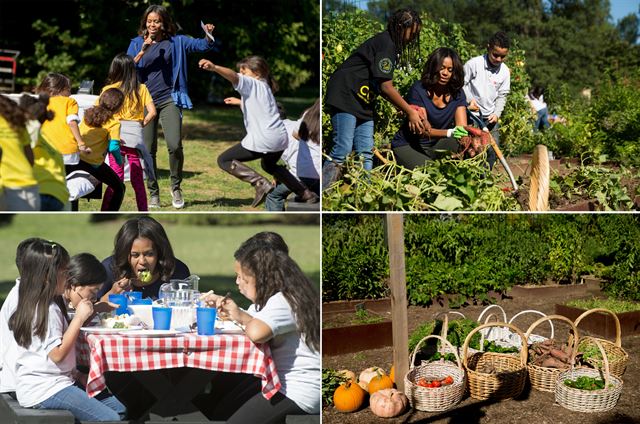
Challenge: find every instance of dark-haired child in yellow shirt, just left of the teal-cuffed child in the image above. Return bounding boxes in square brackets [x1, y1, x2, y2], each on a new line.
[36, 72, 87, 166]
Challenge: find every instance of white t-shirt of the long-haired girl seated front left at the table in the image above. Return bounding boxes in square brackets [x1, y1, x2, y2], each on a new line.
[16, 303, 76, 408]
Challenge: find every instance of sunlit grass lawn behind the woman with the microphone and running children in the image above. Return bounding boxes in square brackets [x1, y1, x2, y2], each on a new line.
[79, 89, 317, 211]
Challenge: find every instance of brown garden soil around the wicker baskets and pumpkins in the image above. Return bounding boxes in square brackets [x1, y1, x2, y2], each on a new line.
[322, 295, 640, 424]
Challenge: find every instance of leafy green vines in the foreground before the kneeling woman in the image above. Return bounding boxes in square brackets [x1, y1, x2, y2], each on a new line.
[322, 155, 519, 211]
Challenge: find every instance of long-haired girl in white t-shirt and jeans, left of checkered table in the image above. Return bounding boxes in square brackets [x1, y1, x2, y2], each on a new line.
[9, 240, 125, 421]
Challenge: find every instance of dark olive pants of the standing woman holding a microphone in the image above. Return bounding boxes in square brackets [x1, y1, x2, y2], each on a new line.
[143, 99, 184, 196]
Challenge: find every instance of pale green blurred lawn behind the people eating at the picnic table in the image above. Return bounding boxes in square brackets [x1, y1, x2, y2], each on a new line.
[0, 214, 320, 306]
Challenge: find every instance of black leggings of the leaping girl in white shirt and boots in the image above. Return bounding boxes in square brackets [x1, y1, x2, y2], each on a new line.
[218, 143, 307, 195]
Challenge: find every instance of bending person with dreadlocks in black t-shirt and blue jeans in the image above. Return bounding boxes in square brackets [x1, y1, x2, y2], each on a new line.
[322, 9, 428, 190]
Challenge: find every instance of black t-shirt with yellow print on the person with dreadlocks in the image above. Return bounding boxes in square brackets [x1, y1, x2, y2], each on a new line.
[324, 31, 396, 121]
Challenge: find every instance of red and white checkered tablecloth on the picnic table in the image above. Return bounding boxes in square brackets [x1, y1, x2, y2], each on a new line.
[77, 333, 280, 399]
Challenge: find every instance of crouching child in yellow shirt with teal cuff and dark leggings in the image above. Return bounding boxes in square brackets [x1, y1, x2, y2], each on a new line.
[67, 88, 124, 211]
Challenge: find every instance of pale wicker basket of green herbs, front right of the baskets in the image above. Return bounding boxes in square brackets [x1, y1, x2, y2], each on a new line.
[556, 339, 622, 412]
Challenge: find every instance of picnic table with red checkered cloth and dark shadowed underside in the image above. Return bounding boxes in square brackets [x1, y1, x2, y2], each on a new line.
[77, 332, 281, 421]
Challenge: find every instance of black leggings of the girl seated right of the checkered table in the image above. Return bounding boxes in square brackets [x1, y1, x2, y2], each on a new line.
[227, 392, 306, 424]
